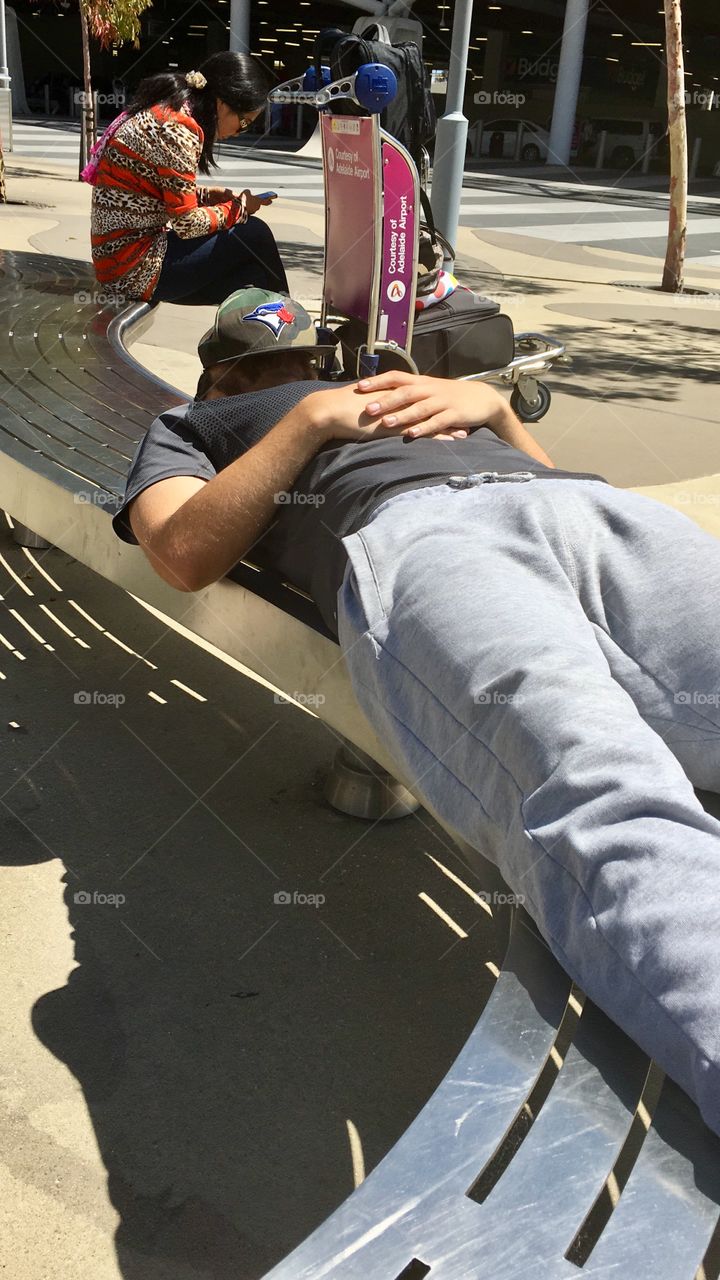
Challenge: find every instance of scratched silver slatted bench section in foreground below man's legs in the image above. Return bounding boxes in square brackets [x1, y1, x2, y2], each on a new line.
[266, 911, 720, 1280]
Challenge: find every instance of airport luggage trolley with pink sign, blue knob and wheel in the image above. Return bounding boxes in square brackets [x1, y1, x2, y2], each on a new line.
[269, 63, 565, 422]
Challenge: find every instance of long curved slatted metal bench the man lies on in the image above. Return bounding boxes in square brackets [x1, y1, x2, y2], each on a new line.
[0, 251, 720, 1280]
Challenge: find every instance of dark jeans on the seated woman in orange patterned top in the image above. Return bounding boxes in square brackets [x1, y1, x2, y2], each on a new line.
[152, 218, 288, 306]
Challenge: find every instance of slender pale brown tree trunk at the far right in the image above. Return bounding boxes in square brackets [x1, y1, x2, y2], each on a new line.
[662, 0, 688, 293]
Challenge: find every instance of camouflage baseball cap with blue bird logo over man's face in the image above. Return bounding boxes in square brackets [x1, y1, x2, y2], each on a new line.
[197, 288, 336, 369]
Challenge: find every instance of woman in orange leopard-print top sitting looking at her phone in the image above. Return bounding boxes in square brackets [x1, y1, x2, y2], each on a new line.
[89, 52, 287, 305]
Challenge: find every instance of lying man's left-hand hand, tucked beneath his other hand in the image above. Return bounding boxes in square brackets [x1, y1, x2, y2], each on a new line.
[305, 374, 468, 442]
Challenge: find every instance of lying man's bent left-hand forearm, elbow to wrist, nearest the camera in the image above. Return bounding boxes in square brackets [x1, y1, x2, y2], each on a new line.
[158, 397, 325, 590]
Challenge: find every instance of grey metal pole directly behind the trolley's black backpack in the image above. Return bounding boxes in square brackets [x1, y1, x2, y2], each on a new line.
[433, 0, 473, 269]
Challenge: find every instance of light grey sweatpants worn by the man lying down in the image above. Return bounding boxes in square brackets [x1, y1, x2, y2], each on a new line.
[338, 479, 720, 1133]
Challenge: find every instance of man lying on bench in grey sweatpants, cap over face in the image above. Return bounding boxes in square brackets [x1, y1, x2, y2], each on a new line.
[115, 291, 720, 1133]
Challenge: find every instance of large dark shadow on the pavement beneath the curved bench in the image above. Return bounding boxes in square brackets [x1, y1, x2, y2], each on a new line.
[0, 536, 502, 1280]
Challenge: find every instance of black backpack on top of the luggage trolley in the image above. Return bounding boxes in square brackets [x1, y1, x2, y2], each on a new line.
[315, 24, 436, 166]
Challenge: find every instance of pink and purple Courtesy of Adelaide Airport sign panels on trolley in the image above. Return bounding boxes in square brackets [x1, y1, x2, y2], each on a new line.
[320, 114, 419, 352]
